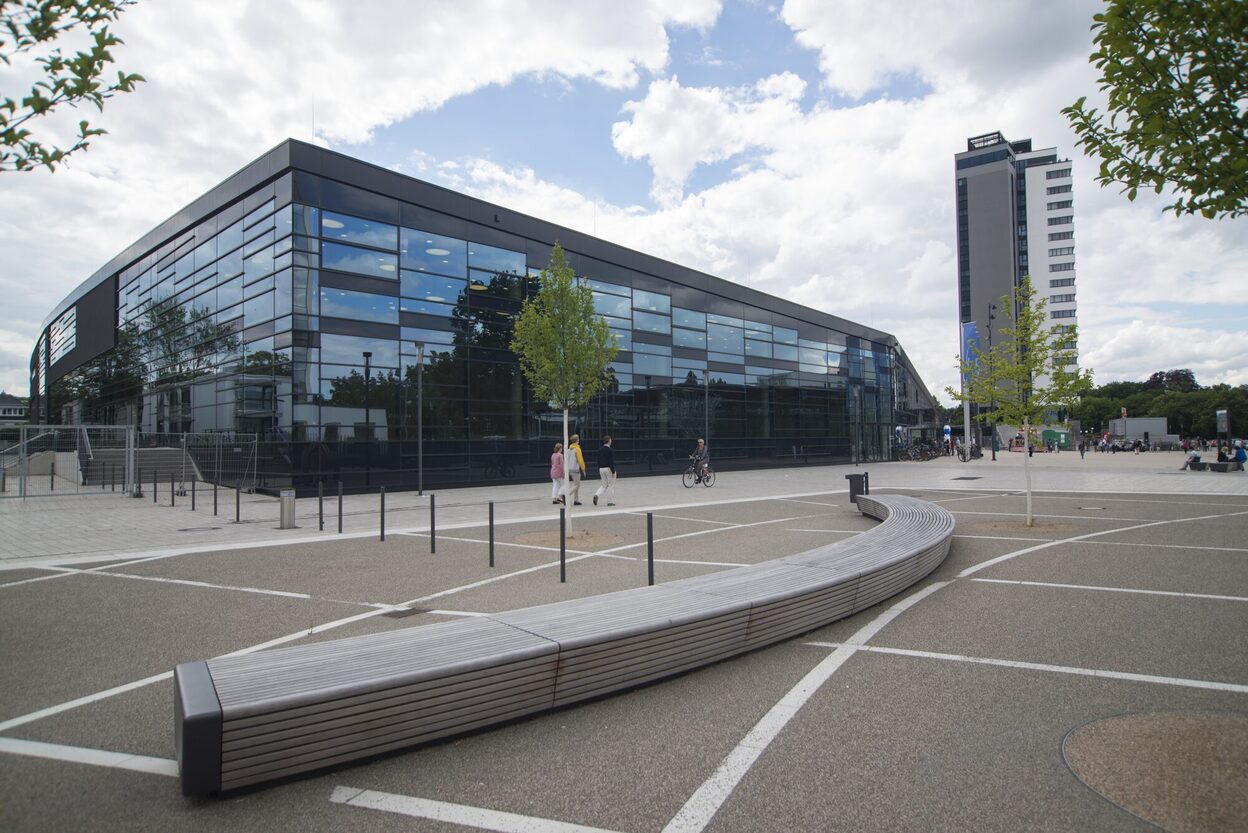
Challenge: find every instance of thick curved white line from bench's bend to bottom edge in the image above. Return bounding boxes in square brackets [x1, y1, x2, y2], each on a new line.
[663, 582, 948, 833]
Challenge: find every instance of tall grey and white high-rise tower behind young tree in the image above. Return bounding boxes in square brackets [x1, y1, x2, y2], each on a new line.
[953, 132, 1078, 382]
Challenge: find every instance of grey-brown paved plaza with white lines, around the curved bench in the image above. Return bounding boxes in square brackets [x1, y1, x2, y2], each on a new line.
[0, 452, 1248, 833]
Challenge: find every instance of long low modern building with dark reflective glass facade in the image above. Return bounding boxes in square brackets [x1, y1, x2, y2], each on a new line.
[30, 140, 935, 490]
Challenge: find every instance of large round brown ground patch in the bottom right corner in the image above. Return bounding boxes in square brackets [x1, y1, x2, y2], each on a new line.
[1062, 712, 1248, 833]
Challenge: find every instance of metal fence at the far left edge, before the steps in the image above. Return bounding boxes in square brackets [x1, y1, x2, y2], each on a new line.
[0, 425, 136, 498]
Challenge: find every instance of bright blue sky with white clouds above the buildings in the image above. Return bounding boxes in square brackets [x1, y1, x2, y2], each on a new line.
[0, 0, 1248, 402]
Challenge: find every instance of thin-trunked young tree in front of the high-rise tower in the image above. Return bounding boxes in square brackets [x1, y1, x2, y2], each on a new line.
[945, 275, 1092, 526]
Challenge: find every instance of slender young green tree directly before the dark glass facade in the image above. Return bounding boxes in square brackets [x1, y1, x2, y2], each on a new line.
[512, 244, 619, 510]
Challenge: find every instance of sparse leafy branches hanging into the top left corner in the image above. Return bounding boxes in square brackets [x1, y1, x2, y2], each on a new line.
[0, 0, 144, 172]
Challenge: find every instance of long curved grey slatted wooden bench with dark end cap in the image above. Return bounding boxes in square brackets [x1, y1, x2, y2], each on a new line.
[175, 495, 953, 796]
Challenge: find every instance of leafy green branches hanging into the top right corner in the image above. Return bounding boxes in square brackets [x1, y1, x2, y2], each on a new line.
[1062, 0, 1248, 217]
